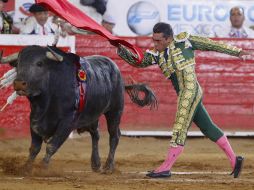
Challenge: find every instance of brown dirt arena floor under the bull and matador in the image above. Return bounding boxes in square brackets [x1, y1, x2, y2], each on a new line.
[0, 132, 254, 190]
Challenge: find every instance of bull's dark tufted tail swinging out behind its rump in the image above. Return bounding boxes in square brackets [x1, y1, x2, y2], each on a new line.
[125, 83, 158, 109]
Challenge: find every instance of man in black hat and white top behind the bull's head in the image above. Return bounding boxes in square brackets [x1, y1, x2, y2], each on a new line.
[20, 4, 57, 35]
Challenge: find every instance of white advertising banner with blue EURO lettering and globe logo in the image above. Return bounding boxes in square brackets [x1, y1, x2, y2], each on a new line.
[107, 0, 254, 36]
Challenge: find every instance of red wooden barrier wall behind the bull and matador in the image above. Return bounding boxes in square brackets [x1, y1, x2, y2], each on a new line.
[0, 35, 254, 135]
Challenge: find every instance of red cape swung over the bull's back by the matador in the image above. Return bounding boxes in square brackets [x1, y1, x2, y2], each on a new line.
[36, 0, 143, 63]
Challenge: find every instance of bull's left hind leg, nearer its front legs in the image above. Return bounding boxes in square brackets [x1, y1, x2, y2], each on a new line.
[89, 121, 101, 172]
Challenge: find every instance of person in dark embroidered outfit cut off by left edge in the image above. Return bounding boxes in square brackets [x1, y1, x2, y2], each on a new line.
[0, 0, 13, 34]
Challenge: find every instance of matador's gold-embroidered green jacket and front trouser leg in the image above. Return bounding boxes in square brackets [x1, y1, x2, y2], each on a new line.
[118, 32, 241, 146]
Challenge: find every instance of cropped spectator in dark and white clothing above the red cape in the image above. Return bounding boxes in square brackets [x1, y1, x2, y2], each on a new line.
[71, 0, 106, 24]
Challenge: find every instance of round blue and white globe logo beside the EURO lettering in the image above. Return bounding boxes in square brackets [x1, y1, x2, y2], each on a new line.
[127, 1, 160, 35]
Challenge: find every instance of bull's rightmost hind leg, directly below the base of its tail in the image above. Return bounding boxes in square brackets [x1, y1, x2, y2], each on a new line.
[103, 111, 122, 173]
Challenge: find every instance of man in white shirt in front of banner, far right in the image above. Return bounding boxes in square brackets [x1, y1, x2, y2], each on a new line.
[214, 7, 254, 38]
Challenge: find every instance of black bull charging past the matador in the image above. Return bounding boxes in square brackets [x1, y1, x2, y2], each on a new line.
[2, 46, 156, 172]
